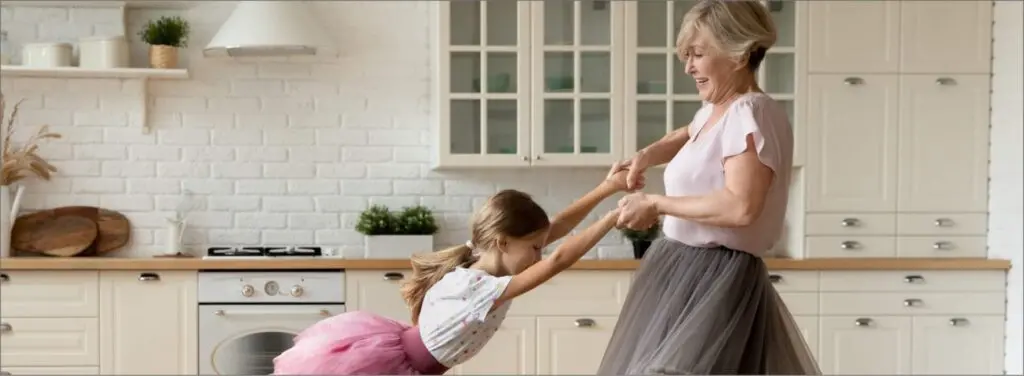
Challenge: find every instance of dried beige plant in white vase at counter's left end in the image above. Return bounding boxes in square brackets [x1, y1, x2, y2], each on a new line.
[0, 94, 60, 257]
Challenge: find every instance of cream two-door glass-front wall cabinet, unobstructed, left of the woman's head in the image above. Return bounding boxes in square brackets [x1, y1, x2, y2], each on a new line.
[437, 0, 623, 167]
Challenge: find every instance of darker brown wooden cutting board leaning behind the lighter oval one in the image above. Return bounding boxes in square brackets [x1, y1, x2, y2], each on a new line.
[11, 206, 131, 256]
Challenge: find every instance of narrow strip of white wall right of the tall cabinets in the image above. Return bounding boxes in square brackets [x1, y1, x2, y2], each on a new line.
[988, 1, 1024, 375]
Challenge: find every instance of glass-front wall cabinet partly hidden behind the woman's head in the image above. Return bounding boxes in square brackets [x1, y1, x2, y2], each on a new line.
[623, 0, 801, 165]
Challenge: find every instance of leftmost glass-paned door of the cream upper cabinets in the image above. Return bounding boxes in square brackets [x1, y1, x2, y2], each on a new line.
[438, 0, 530, 166]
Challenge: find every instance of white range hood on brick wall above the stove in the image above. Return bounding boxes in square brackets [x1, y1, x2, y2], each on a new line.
[203, 0, 333, 56]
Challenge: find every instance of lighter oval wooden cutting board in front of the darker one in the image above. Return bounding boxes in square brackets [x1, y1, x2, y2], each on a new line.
[11, 215, 98, 257]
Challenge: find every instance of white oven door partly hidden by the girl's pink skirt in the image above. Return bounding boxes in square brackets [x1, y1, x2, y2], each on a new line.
[199, 304, 345, 375]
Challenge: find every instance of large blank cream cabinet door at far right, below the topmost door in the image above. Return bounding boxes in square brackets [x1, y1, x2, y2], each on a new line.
[896, 75, 991, 213]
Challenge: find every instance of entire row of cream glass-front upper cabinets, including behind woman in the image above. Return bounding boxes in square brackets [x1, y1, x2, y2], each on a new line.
[435, 0, 800, 167]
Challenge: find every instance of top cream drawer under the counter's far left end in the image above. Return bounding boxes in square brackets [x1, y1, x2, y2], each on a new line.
[0, 270, 99, 319]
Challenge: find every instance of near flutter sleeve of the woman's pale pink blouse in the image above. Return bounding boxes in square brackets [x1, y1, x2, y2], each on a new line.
[721, 97, 792, 172]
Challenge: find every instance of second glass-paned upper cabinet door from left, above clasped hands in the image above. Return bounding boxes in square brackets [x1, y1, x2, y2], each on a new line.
[530, 0, 625, 166]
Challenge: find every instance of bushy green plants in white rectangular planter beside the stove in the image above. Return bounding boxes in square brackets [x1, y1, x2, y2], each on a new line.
[355, 205, 437, 258]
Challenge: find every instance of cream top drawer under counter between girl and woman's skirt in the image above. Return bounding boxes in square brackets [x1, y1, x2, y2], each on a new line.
[509, 270, 631, 316]
